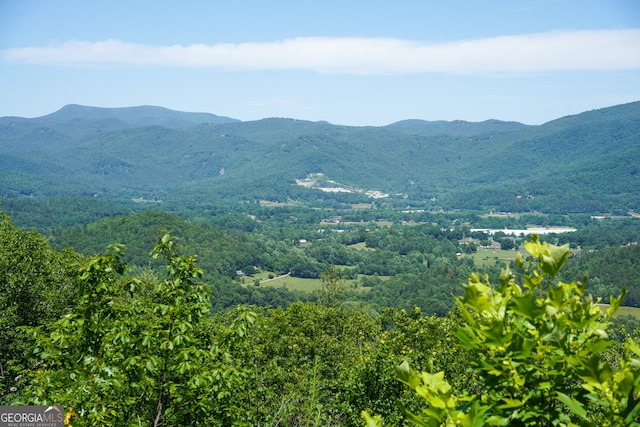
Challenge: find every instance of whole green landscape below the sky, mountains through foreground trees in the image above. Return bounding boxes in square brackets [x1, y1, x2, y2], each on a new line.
[0, 99, 640, 427]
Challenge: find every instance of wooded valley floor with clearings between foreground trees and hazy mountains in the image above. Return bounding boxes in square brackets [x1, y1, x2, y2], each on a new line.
[2, 199, 640, 315]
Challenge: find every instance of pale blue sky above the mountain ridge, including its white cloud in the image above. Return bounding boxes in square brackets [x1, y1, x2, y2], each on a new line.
[0, 0, 640, 126]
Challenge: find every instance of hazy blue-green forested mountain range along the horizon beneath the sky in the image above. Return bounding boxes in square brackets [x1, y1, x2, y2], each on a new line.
[0, 102, 640, 213]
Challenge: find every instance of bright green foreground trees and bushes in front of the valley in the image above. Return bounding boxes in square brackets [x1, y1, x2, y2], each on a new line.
[0, 209, 640, 426]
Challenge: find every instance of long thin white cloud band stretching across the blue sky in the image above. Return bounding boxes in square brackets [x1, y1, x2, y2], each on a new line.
[3, 29, 640, 75]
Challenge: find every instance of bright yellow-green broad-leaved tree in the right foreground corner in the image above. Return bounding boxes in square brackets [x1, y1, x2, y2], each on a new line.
[384, 236, 640, 426]
